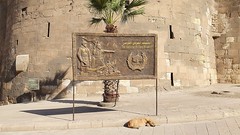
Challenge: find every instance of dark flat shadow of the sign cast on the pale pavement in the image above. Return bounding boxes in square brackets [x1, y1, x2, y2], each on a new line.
[22, 106, 115, 116]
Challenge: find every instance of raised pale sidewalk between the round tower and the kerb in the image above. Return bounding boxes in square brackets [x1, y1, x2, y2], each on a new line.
[0, 84, 240, 131]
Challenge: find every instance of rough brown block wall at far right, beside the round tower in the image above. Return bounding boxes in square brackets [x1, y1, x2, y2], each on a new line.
[215, 0, 240, 83]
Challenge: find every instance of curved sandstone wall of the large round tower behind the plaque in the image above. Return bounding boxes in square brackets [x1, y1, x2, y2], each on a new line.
[1, 0, 216, 100]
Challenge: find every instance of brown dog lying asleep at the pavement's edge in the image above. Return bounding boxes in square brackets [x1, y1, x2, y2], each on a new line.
[126, 118, 155, 129]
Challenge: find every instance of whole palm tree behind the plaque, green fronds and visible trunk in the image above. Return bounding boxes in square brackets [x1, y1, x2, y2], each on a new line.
[88, 0, 147, 102]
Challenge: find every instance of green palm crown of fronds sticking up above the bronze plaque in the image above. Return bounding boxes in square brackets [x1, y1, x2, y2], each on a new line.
[89, 0, 147, 33]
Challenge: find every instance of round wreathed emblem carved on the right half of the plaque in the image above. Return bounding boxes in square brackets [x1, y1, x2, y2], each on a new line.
[127, 52, 147, 71]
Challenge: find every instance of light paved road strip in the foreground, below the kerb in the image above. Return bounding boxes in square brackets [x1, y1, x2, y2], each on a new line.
[0, 117, 240, 135]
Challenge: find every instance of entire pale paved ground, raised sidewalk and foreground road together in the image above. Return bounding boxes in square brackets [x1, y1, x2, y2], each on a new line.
[0, 84, 240, 135]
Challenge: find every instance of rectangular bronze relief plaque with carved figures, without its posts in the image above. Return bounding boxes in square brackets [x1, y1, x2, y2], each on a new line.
[72, 33, 157, 80]
